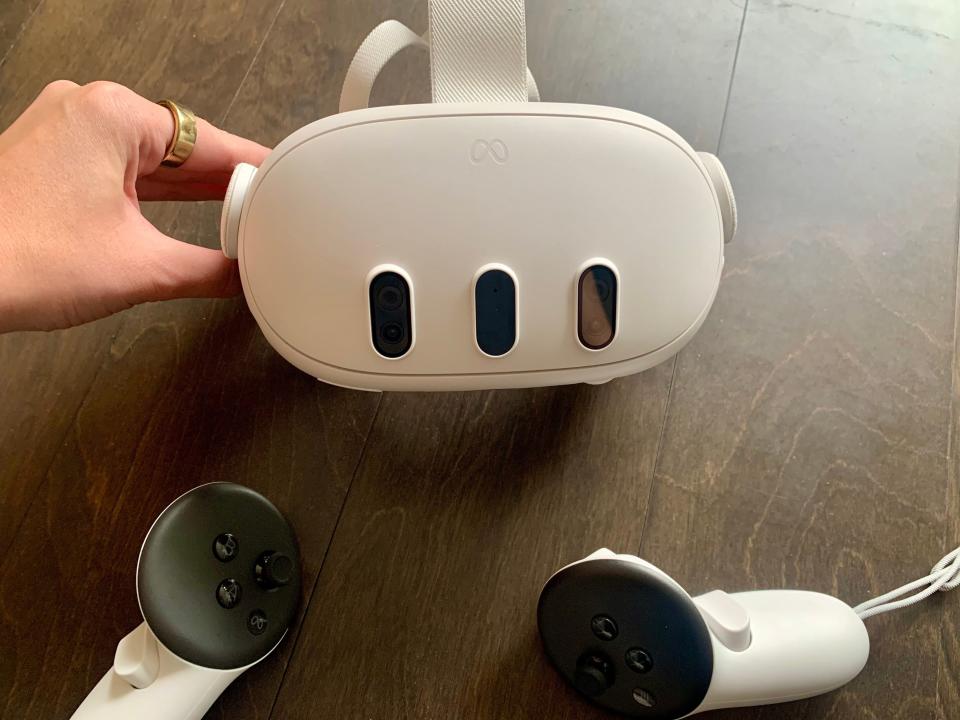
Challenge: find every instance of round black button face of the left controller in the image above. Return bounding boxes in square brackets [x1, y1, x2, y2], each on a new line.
[137, 483, 300, 670]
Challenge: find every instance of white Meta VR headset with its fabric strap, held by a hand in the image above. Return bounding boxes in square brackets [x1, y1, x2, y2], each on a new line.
[221, 0, 737, 390]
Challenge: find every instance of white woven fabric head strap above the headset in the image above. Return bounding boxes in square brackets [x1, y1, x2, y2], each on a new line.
[340, 0, 540, 112]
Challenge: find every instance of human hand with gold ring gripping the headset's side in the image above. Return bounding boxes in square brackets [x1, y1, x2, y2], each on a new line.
[0, 81, 269, 332]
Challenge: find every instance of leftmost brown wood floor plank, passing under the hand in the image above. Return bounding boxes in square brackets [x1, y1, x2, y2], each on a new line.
[0, 0, 279, 551]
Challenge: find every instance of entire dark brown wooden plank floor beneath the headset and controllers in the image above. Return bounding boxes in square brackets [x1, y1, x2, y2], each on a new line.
[0, 0, 960, 720]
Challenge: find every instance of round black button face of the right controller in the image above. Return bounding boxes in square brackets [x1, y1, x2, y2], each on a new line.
[537, 558, 713, 720]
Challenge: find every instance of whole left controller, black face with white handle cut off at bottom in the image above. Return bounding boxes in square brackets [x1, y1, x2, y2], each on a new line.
[73, 483, 300, 720]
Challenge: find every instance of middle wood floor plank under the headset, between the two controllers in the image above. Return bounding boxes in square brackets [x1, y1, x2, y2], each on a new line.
[265, 0, 741, 719]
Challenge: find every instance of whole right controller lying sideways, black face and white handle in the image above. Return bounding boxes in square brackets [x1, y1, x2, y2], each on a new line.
[538, 549, 870, 720]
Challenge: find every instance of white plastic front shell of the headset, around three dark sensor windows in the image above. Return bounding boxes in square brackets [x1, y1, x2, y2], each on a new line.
[231, 103, 724, 390]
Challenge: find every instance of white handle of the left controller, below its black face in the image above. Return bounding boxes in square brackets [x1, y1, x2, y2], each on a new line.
[72, 623, 249, 720]
